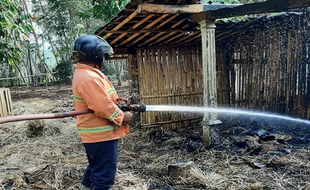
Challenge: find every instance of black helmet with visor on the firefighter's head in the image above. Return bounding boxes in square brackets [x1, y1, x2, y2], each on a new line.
[73, 35, 114, 67]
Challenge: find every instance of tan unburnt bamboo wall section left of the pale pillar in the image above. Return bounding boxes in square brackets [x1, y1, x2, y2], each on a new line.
[137, 46, 203, 129]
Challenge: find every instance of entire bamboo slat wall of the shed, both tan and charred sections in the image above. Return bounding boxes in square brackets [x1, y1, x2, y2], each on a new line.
[136, 13, 310, 129]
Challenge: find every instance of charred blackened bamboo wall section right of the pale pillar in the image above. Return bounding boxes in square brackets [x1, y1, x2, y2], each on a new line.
[217, 13, 310, 119]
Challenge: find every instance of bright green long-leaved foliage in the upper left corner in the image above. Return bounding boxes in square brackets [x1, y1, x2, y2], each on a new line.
[0, 0, 32, 68]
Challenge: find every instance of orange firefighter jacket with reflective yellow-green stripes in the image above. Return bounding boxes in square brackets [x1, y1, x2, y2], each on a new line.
[72, 64, 129, 143]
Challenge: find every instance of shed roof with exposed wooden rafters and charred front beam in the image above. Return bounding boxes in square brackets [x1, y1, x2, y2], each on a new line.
[95, 0, 310, 54]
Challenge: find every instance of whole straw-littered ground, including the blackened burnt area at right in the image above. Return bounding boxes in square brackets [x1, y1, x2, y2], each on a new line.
[0, 85, 310, 190]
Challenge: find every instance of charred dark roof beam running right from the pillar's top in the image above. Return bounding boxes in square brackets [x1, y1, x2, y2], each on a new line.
[191, 0, 310, 22]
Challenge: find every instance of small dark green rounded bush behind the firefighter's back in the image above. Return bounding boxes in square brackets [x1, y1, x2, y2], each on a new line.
[53, 61, 73, 84]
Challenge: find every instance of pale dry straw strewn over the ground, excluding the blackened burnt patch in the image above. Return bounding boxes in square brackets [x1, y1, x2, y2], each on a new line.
[0, 89, 310, 190]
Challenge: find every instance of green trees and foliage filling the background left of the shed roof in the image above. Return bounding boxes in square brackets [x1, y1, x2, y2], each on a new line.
[0, 0, 129, 86]
